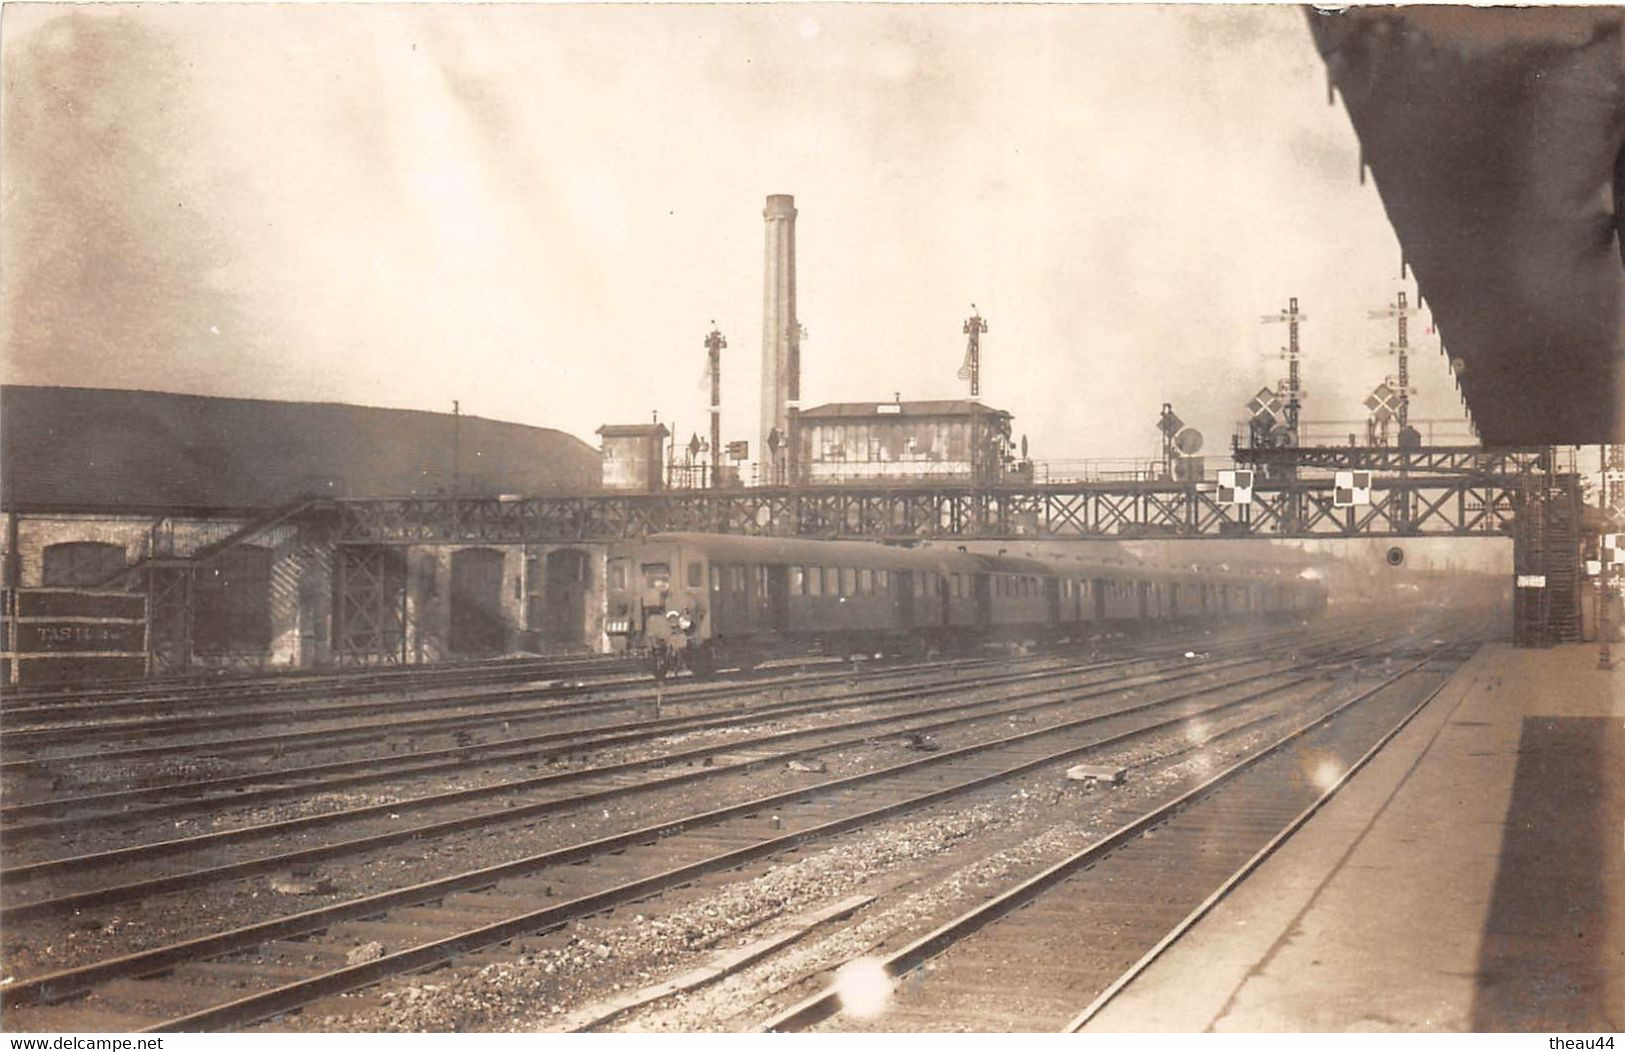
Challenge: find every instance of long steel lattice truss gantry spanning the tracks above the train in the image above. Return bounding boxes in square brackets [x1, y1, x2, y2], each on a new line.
[326, 475, 1519, 545]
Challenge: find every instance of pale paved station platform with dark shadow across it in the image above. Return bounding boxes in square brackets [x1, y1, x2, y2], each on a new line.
[1086, 644, 1625, 1034]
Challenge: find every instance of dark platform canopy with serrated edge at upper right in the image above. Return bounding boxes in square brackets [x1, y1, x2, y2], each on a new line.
[1308, 7, 1625, 446]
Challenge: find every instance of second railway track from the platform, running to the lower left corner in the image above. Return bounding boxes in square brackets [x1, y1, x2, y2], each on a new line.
[3, 614, 1423, 1029]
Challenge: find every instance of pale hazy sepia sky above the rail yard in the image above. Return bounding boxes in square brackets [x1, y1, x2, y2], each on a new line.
[0, 3, 1466, 460]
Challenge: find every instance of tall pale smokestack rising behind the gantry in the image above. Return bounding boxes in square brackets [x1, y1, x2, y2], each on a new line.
[757, 193, 801, 481]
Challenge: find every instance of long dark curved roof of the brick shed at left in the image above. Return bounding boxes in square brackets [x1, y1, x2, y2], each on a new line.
[0, 385, 601, 512]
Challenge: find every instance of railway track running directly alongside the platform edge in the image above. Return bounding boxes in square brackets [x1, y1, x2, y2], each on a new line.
[761, 644, 1476, 1031]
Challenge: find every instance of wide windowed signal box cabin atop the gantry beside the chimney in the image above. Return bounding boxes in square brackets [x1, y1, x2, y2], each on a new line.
[798, 398, 1011, 486]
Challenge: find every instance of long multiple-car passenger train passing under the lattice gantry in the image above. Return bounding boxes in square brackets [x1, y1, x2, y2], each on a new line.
[605, 533, 1326, 678]
